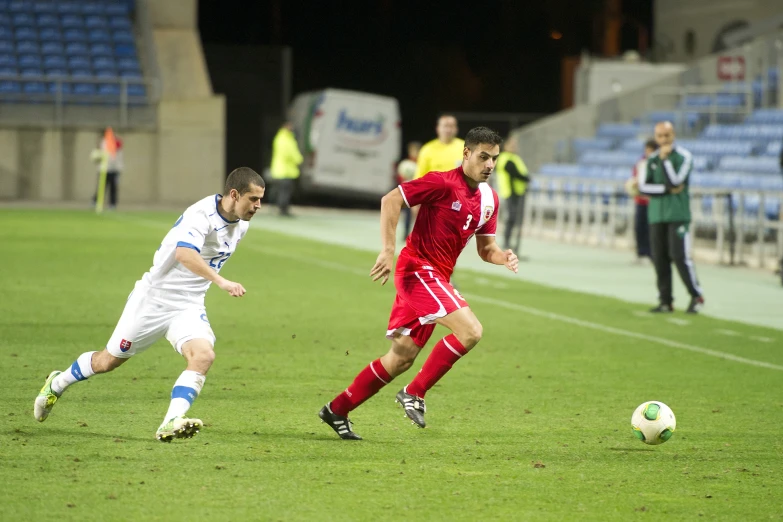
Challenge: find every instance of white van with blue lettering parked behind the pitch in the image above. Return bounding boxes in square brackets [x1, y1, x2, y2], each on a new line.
[290, 89, 401, 199]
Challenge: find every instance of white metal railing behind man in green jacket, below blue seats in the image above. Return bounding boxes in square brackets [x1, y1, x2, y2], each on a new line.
[524, 174, 783, 268]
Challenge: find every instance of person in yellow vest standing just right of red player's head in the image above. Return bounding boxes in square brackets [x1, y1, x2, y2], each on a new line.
[495, 137, 530, 251]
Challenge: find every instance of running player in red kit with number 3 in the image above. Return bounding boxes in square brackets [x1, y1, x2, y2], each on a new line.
[318, 127, 519, 440]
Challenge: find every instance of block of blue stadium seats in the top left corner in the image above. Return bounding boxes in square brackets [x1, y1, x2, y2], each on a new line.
[0, 0, 148, 104]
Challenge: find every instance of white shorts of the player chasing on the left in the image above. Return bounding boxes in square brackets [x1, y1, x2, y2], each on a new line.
[106, 281, 215, 359]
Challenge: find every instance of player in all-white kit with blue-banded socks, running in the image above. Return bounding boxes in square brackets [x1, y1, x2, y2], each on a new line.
[34, 167, 265, 442]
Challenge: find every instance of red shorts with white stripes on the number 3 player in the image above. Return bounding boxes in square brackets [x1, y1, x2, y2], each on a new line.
[386, 260, 469, 348]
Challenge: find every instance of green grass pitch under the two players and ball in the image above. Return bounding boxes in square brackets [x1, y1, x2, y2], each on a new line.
[0, 210, 783, 521]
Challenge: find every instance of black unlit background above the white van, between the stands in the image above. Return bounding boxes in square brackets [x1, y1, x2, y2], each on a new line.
[199, 0, 652, 175]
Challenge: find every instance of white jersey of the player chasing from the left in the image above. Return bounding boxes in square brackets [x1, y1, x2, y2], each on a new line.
[141, 194, 250, 300]
